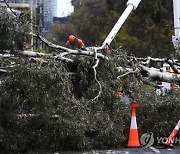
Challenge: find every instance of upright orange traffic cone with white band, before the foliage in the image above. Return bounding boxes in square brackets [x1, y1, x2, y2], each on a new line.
[127, 102, 140, 147]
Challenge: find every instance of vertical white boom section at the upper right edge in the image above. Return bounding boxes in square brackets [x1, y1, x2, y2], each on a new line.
[172, 0, 180, 49]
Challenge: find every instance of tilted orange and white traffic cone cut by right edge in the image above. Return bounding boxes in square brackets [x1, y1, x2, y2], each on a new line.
[164, 120, 180, 148]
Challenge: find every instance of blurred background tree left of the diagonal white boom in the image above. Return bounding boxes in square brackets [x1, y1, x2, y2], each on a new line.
[49, 0, 118, 46]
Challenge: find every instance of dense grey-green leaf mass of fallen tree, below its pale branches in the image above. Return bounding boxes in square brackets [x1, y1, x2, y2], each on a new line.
[0, 56, 180, 153]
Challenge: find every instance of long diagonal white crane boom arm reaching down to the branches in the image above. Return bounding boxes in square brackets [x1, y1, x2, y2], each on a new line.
[102, 0, 141, 48]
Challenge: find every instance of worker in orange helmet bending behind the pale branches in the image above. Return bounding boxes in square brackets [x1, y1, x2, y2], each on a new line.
[65, 35, 86, 50]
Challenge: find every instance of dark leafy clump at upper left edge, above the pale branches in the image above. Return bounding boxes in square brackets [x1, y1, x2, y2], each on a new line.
[0, 9, 29, 53]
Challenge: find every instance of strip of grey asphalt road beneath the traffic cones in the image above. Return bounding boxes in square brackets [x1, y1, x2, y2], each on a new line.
[60, 147, 180, 154]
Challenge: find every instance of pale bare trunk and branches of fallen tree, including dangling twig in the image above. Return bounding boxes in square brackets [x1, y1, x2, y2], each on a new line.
[1, 34, 180, 99]
